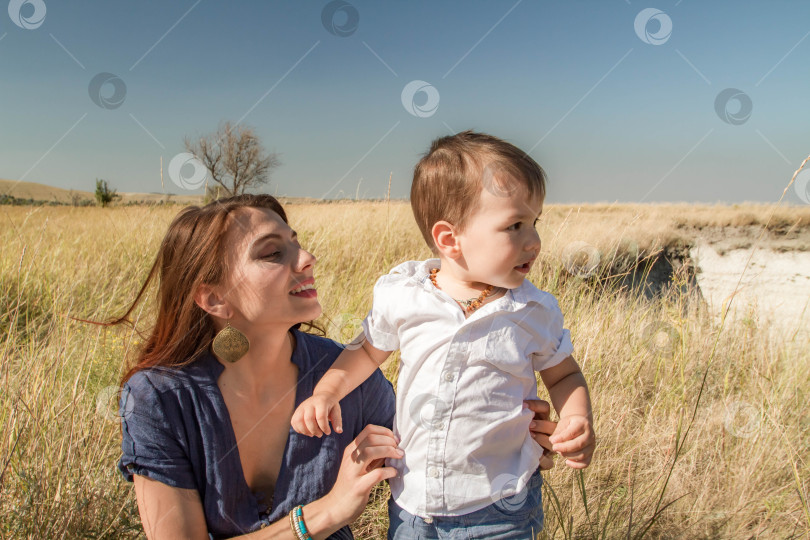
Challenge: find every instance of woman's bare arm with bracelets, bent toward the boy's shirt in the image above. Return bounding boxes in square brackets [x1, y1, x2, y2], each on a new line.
[134, 425, 402, 540]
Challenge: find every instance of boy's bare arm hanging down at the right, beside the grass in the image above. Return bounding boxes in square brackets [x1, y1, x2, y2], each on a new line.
[540, 356, 596, 469]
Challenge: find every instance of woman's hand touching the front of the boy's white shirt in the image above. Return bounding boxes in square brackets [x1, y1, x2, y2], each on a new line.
[318, 425, 405, 524]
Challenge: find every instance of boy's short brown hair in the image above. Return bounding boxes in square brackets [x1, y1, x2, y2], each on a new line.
[411, 131, 546, 252]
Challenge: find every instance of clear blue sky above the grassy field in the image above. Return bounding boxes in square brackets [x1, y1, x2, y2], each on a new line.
[0, 0, 810, 204]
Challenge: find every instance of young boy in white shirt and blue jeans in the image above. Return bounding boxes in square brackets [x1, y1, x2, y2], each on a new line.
[292, 131, 594, 539]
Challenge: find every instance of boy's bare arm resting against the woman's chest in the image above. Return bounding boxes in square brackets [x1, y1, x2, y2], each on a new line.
[290, 340, 391, 437]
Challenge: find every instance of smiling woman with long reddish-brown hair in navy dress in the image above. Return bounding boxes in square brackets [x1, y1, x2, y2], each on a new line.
[102, 195, 554, 539]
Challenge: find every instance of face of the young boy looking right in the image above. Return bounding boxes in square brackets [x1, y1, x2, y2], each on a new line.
[456, 181, 543, 289]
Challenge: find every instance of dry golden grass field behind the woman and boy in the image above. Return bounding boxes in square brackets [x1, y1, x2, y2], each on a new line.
[0, 202, 810, 539]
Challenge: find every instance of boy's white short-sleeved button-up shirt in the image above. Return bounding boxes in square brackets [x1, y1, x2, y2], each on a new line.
[363, 259, 573, 518]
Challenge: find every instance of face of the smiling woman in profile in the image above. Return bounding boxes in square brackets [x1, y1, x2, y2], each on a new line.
[221, 208, 321, 330]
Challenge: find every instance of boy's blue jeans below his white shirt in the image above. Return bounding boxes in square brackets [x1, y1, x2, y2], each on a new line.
[388, 470, 543, 540]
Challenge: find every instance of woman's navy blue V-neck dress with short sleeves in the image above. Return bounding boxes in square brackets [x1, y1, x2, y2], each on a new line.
[118, 330, 394, 539]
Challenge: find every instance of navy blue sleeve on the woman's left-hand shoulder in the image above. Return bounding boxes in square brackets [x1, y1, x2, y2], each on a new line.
[118, 372, 197, 489]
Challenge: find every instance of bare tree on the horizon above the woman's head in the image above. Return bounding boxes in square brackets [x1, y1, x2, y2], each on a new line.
[184, 122, 281, 196]
